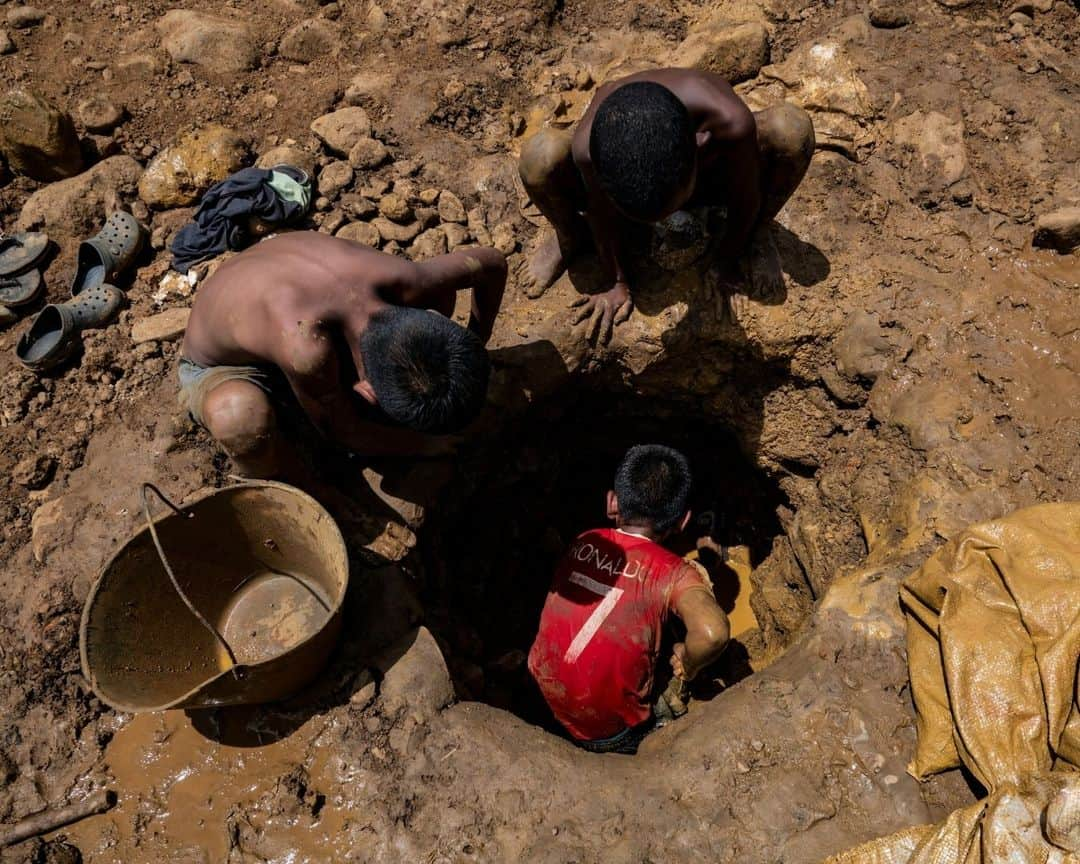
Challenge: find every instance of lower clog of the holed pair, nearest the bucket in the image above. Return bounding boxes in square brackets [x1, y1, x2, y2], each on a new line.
[15, 283, 124, 372]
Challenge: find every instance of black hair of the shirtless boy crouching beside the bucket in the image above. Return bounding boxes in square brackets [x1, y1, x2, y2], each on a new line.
[360, 306, 490, 434]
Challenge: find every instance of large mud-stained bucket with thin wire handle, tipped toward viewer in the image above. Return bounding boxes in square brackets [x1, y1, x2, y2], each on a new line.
[79, 482, 349, 712]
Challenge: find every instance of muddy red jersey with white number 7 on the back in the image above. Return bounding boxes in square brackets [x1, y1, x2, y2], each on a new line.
[529, 528, 704, 741]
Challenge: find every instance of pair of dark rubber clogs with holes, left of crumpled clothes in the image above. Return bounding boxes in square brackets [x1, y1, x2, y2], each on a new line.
[15, 212, 145, 372]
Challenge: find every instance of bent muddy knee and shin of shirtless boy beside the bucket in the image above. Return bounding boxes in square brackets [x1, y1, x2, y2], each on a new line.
[202, 380, 285, 477]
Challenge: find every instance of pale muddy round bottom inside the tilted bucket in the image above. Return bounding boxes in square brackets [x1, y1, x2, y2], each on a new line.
[217, 570, 330, 669]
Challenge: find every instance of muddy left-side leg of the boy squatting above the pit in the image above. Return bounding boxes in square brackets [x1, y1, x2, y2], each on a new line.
[517, 129, 589, 297]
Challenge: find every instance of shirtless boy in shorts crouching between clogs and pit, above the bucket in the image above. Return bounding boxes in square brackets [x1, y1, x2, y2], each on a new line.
[179, 231, 507, 477]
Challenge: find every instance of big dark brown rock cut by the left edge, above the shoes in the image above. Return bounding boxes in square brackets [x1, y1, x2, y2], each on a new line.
[0, 87, 82, 180]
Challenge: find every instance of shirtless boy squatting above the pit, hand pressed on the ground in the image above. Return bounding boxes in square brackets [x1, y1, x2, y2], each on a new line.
[518, 69, 814, 341]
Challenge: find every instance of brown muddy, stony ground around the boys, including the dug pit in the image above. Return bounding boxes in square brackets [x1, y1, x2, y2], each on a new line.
[0, 0, 1080, 863]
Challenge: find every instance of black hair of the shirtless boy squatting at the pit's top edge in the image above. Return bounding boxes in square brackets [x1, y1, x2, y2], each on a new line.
[589, 81, 697, 221]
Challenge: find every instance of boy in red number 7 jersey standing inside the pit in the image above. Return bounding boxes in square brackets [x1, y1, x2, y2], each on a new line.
[529, 444, 728, 753]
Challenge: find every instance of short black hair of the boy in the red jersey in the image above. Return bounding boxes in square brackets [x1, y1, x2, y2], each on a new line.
[615, 444, 693, 534]
